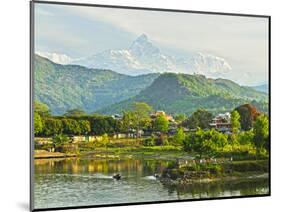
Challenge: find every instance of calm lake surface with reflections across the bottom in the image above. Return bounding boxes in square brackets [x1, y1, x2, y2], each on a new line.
[34, 158, 269, 209]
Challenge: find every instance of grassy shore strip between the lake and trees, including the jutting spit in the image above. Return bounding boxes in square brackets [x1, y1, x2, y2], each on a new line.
[34, 134, 269, 185]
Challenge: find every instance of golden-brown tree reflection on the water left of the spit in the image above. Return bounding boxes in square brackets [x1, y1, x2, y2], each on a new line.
[34, 158, 170, 176]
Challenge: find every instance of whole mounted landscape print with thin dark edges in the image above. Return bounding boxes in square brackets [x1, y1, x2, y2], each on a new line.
[30, 1, 271, 211]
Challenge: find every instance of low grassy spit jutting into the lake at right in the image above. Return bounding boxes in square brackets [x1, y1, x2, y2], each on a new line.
[160, 160, 269, 186]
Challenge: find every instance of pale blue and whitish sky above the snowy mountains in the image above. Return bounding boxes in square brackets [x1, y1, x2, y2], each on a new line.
[35, 3, 268, 85]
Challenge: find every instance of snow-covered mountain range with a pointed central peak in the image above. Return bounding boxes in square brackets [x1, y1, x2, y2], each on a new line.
[36, 34, 232, 78]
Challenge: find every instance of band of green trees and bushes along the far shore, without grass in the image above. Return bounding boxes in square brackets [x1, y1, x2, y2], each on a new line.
[34, 98, 269, 160]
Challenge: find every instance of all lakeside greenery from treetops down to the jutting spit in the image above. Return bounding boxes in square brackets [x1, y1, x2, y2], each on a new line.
[34, 99, 269, 183]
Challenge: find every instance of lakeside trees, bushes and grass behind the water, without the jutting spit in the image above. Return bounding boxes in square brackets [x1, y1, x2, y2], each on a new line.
[34, 102, 269, 158]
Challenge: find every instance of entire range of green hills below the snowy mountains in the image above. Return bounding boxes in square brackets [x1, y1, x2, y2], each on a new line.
[34, 55, 268, 115]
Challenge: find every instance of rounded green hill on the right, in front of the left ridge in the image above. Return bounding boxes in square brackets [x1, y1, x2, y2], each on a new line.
[97, 73, 268, 114]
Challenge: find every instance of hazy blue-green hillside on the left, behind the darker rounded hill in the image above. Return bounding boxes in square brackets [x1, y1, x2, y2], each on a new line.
[34, 55, 159, 114]
